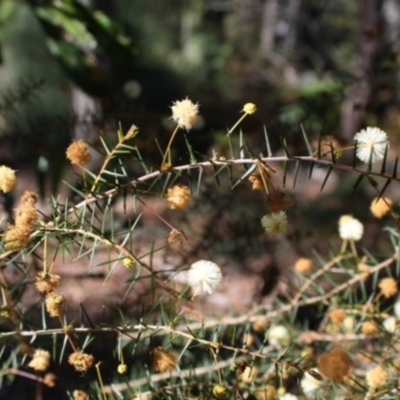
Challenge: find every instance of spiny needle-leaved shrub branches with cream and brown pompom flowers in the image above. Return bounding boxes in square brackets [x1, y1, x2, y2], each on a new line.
[0, 98, 400, 400]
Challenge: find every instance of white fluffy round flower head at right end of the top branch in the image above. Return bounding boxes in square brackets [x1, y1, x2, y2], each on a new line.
[353, 127, 389, 163]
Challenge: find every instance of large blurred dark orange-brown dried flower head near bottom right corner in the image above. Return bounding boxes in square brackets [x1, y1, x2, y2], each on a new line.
[318, 347, 352, 383]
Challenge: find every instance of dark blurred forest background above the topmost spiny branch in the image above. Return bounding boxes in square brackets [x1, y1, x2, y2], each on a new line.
[0, 0, 400, 192]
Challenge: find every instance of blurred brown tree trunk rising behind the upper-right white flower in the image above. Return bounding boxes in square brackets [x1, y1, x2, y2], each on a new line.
[340, 0, 383, 144]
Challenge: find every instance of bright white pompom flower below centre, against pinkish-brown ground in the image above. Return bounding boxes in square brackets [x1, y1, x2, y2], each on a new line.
[188, 260, 222, 295]
